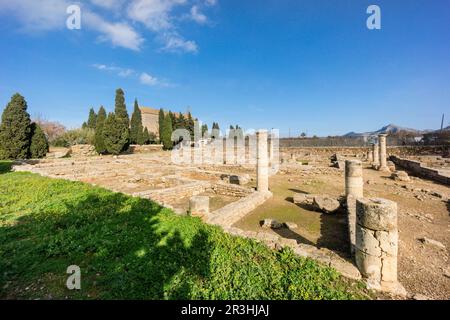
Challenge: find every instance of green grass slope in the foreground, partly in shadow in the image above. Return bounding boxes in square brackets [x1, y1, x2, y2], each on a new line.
[0, 162, 366, 299]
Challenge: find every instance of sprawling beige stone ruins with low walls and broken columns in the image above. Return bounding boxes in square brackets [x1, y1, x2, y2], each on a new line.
[15, 130, 448, 295]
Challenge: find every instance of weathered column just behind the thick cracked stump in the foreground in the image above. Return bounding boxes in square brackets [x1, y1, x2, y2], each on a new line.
[345, 160, 364, 256]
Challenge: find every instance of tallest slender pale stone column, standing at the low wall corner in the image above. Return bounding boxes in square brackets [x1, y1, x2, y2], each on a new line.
[256, 130, 269, 192]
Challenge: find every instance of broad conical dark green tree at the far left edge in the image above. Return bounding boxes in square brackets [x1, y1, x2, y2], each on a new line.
[0, 93, 31, 159]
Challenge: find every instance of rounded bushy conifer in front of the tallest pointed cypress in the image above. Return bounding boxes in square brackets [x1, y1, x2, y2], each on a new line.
[102, 113, 129, 154]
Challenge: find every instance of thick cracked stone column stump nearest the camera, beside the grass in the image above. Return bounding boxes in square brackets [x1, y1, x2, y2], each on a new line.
[355, 198, 405, 294]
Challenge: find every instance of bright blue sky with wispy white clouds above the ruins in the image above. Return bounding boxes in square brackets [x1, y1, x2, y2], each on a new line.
[0, 0, 450, 136]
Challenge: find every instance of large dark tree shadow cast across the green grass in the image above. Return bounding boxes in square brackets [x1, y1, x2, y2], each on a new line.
[0, 192, 212, 299]
